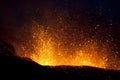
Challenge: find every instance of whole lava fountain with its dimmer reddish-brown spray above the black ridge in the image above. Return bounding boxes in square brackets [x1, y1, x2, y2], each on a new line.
[12, 21, 112, 68]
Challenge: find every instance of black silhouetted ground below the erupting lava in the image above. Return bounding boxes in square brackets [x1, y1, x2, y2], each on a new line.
[0, 55, 120, 80]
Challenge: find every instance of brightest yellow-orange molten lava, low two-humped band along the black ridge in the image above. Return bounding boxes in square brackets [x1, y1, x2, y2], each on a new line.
[31, 39, 107, 68]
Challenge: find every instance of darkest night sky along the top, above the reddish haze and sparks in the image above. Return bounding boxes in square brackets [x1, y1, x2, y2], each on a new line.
[0, 0, 120, 26]
